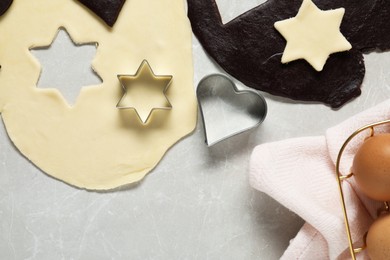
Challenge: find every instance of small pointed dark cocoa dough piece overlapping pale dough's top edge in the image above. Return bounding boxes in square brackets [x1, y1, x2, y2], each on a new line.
[78, 0, 126, 27]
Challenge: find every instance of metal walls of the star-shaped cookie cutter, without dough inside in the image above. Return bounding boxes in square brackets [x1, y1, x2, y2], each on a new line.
[116, 60, 173, 125]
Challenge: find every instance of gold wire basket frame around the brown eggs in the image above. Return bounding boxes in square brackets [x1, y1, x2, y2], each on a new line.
[336, 120, 390, 260]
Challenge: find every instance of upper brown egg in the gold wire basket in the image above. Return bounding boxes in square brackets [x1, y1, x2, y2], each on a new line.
[352, 134, 390, 201]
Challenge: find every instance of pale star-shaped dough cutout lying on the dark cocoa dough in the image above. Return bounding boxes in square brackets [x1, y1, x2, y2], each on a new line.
[274, 0, 352, 71]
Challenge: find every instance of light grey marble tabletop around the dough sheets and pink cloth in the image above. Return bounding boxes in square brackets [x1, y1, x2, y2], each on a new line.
[0, 0, 390, 259]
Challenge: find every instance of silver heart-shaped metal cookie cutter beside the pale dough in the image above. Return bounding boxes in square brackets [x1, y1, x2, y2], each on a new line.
[196, 74, 267, 146]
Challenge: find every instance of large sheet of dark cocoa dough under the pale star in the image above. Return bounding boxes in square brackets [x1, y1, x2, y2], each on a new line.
[187, 0, 390, 108]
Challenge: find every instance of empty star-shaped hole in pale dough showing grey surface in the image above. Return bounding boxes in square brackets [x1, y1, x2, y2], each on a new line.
[30, 28, 102, 104]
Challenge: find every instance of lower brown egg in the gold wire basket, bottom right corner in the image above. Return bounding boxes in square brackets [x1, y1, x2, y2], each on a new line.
[366, 214, 390, 260]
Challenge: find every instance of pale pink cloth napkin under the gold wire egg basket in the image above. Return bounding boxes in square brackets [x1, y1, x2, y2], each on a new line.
[250, 100, 390, 260]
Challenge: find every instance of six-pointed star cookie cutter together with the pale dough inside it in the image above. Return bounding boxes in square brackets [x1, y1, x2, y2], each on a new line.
[117, 60, 172, 124]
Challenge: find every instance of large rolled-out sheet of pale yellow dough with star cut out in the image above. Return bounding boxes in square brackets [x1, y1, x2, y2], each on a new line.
[0, 0, 197, 190]
